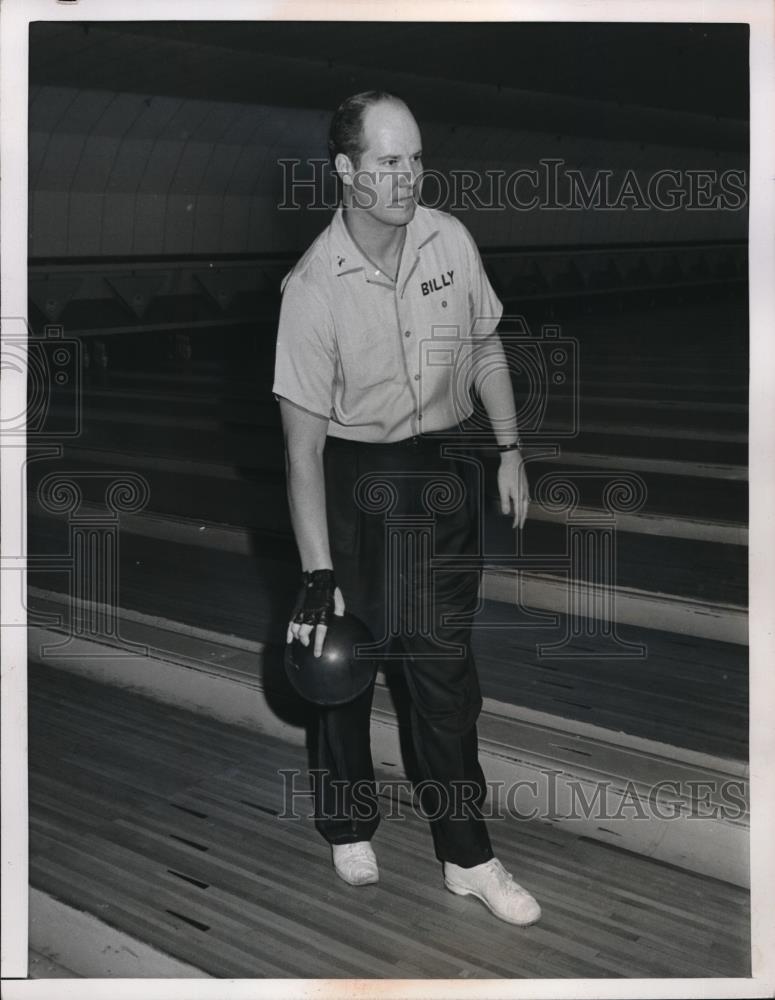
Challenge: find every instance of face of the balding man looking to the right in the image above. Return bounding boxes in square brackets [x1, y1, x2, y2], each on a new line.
[350, 101, 422, 226]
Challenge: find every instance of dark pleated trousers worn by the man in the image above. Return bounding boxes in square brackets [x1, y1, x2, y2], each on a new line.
[313, 428, 493, 867]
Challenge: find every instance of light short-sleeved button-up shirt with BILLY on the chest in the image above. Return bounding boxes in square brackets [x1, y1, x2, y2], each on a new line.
[272, 206, 503, 442]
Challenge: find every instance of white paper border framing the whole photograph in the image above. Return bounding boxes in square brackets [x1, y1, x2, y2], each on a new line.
[0, 0, 775, 1000]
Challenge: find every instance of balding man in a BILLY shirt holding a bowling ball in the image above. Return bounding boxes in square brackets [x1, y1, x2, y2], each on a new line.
[273, 91, 540, 925]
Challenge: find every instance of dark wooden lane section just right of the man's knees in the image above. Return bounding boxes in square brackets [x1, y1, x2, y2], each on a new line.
[473, 603, 748, 760]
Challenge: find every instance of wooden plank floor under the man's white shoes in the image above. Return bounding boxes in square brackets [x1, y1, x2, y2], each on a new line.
[29, 664, 750, 979]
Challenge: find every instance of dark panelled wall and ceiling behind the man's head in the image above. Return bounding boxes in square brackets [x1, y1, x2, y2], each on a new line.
[29, 22, 748, 259]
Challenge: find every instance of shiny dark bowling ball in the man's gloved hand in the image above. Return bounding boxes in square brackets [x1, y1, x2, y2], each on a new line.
[285, 611, 377, 706]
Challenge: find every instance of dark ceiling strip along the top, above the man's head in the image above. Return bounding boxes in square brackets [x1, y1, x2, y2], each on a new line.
[30, 21, 748, 131]
